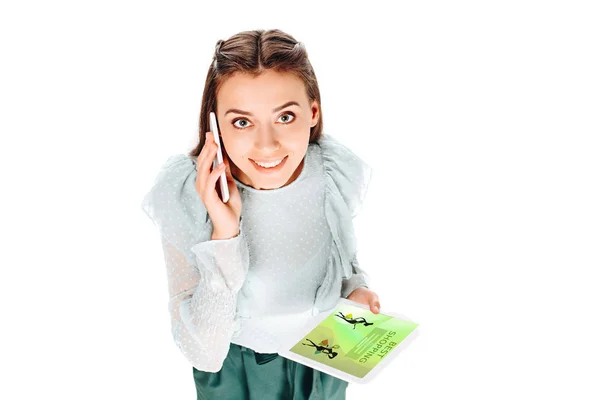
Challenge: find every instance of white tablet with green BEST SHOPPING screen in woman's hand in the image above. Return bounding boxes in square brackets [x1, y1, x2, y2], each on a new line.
[278, 298, 419, 383]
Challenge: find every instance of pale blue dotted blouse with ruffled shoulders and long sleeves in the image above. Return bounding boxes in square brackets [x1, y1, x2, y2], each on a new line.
[142, 134, 372, 372]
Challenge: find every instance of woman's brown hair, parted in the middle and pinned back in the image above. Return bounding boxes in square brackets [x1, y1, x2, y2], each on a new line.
[189, 29, 323, 157]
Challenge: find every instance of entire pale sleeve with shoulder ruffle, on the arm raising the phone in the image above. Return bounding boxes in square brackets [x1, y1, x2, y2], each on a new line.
[142, 155, 249, 372]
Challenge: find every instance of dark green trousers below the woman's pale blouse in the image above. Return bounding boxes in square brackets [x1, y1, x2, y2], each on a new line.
[192, 343, 348, 400]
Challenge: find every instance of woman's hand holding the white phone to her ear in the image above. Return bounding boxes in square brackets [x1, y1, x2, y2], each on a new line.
[196, 132, 242, 240]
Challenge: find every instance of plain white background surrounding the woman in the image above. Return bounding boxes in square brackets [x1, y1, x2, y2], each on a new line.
[0, 0, 600, 399]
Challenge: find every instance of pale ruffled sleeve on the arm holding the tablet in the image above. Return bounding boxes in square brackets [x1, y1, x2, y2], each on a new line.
[318, 135, 372, 298]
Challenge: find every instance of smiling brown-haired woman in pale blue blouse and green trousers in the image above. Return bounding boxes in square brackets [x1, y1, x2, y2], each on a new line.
[143, 30, 379, 400]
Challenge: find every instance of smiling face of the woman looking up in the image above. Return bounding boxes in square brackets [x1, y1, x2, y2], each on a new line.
[216, 70, 319, 189]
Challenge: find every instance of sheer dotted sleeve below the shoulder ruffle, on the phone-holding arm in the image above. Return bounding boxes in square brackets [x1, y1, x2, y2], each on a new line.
[162, 217, 249, 372]
